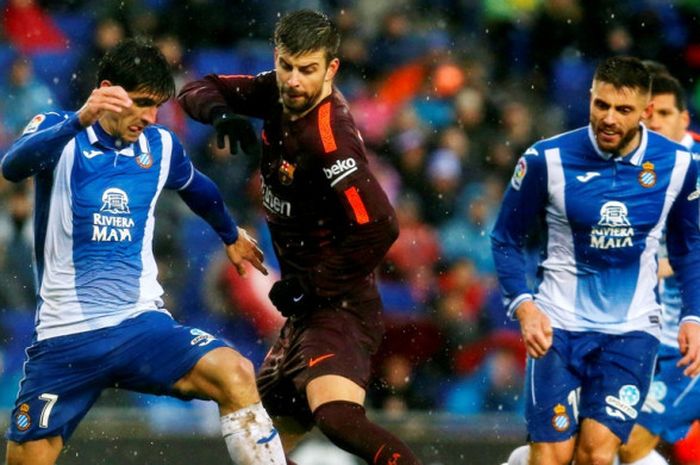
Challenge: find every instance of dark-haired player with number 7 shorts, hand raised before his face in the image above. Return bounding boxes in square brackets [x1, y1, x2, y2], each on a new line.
[1, 39, 284, 465]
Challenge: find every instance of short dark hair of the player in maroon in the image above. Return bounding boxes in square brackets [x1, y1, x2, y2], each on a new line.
[275, 10, 340, 62]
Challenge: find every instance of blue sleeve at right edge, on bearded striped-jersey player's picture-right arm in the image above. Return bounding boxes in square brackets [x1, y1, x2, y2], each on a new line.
[666, 156, 700, 323]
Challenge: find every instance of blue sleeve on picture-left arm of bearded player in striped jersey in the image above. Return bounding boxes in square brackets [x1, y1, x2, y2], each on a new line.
[491, 149, 547, 318]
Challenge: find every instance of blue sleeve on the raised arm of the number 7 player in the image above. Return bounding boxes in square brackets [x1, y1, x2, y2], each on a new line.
[0, 112, 83, 182]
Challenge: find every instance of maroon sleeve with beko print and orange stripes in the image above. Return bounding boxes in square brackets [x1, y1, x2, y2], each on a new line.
[311, 109, 399, 297]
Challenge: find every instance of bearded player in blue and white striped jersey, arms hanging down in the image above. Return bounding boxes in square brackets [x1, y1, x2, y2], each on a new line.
[492, 57, 700, 465]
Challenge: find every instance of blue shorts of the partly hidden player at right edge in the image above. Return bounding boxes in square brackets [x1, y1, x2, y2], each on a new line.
[637, 345, 700, 443]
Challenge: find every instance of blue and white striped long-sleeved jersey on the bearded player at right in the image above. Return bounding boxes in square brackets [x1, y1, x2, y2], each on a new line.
[491, 125, 700, 337]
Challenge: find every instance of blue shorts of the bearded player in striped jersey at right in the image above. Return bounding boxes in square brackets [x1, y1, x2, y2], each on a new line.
[525, 329, 659, 442]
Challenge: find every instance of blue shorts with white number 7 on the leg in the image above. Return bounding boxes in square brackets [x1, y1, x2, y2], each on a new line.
[5, 311, 226, 443]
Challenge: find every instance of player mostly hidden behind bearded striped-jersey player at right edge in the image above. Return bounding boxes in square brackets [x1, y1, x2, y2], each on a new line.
[620, 73, 700, 465]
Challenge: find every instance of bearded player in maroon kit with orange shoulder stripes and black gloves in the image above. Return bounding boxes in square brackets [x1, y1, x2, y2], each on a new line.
[178, 10, 420, 465]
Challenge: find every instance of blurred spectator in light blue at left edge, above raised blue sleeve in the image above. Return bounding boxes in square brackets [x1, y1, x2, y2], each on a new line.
[0, 56, 58, 138]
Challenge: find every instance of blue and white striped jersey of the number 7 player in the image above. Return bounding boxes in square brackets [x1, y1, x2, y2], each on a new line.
[3, 112, 195, 340]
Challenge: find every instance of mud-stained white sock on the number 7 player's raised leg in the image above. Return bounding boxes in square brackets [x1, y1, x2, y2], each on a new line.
[221, 402, 287, 465]
